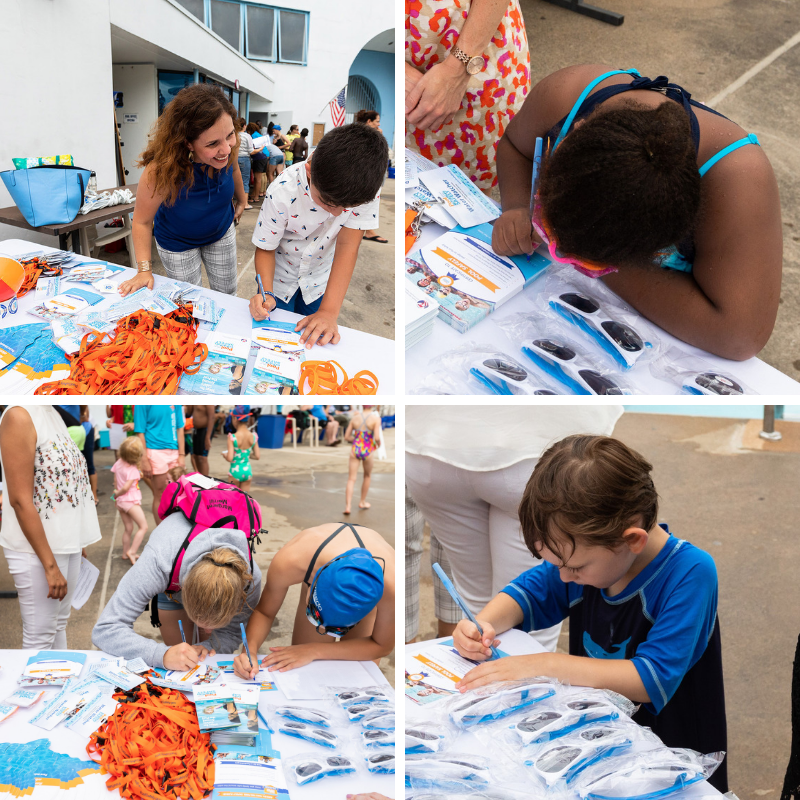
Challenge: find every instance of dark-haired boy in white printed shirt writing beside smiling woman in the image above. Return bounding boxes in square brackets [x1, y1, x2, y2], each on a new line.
[250, 124, 389, 347]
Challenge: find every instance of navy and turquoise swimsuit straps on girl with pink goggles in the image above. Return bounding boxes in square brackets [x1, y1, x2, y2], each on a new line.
[548, 69, 759, 272]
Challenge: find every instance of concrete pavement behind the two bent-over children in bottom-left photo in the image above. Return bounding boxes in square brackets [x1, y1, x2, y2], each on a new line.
[0, 429, 395, 683]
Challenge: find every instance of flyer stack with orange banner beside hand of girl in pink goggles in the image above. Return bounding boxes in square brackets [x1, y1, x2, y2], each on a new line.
[406, 224, 550, 333]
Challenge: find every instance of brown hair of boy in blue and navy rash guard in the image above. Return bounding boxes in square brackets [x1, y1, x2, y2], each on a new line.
[519, 435, 658, 561]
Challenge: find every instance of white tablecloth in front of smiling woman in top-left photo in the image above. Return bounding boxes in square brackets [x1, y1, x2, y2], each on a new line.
[0, 239, 395, 395]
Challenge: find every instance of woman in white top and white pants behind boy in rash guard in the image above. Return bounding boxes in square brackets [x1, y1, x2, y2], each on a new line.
[406, 404, 622, 651]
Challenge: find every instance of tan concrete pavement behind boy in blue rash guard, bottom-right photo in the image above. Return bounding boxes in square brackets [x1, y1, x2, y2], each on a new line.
[410, 416, 800, 800]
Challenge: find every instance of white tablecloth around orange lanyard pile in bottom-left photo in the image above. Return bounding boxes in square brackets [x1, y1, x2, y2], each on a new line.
[0, 650, 394, 800]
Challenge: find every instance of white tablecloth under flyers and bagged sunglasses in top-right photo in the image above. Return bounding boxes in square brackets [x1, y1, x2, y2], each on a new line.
[401, 222, 800, 395]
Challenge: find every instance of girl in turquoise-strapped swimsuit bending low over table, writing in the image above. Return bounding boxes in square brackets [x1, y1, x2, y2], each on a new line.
[492, 64, 783, 360]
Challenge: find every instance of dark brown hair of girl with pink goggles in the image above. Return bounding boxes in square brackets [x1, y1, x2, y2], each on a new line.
[539, 101, 700, 266]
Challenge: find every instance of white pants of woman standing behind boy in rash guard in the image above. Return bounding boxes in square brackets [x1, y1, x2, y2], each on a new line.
[406, 453, 561, 651]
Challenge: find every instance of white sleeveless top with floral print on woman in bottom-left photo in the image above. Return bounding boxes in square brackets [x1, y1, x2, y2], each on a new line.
[0, 406, 100, 554]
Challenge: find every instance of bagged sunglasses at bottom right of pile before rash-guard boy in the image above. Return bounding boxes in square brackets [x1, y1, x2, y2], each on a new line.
[575, 747, 725, 800]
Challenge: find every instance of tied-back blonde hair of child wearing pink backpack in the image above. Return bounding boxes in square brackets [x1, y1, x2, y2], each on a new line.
[181, 547, 253, 629]
